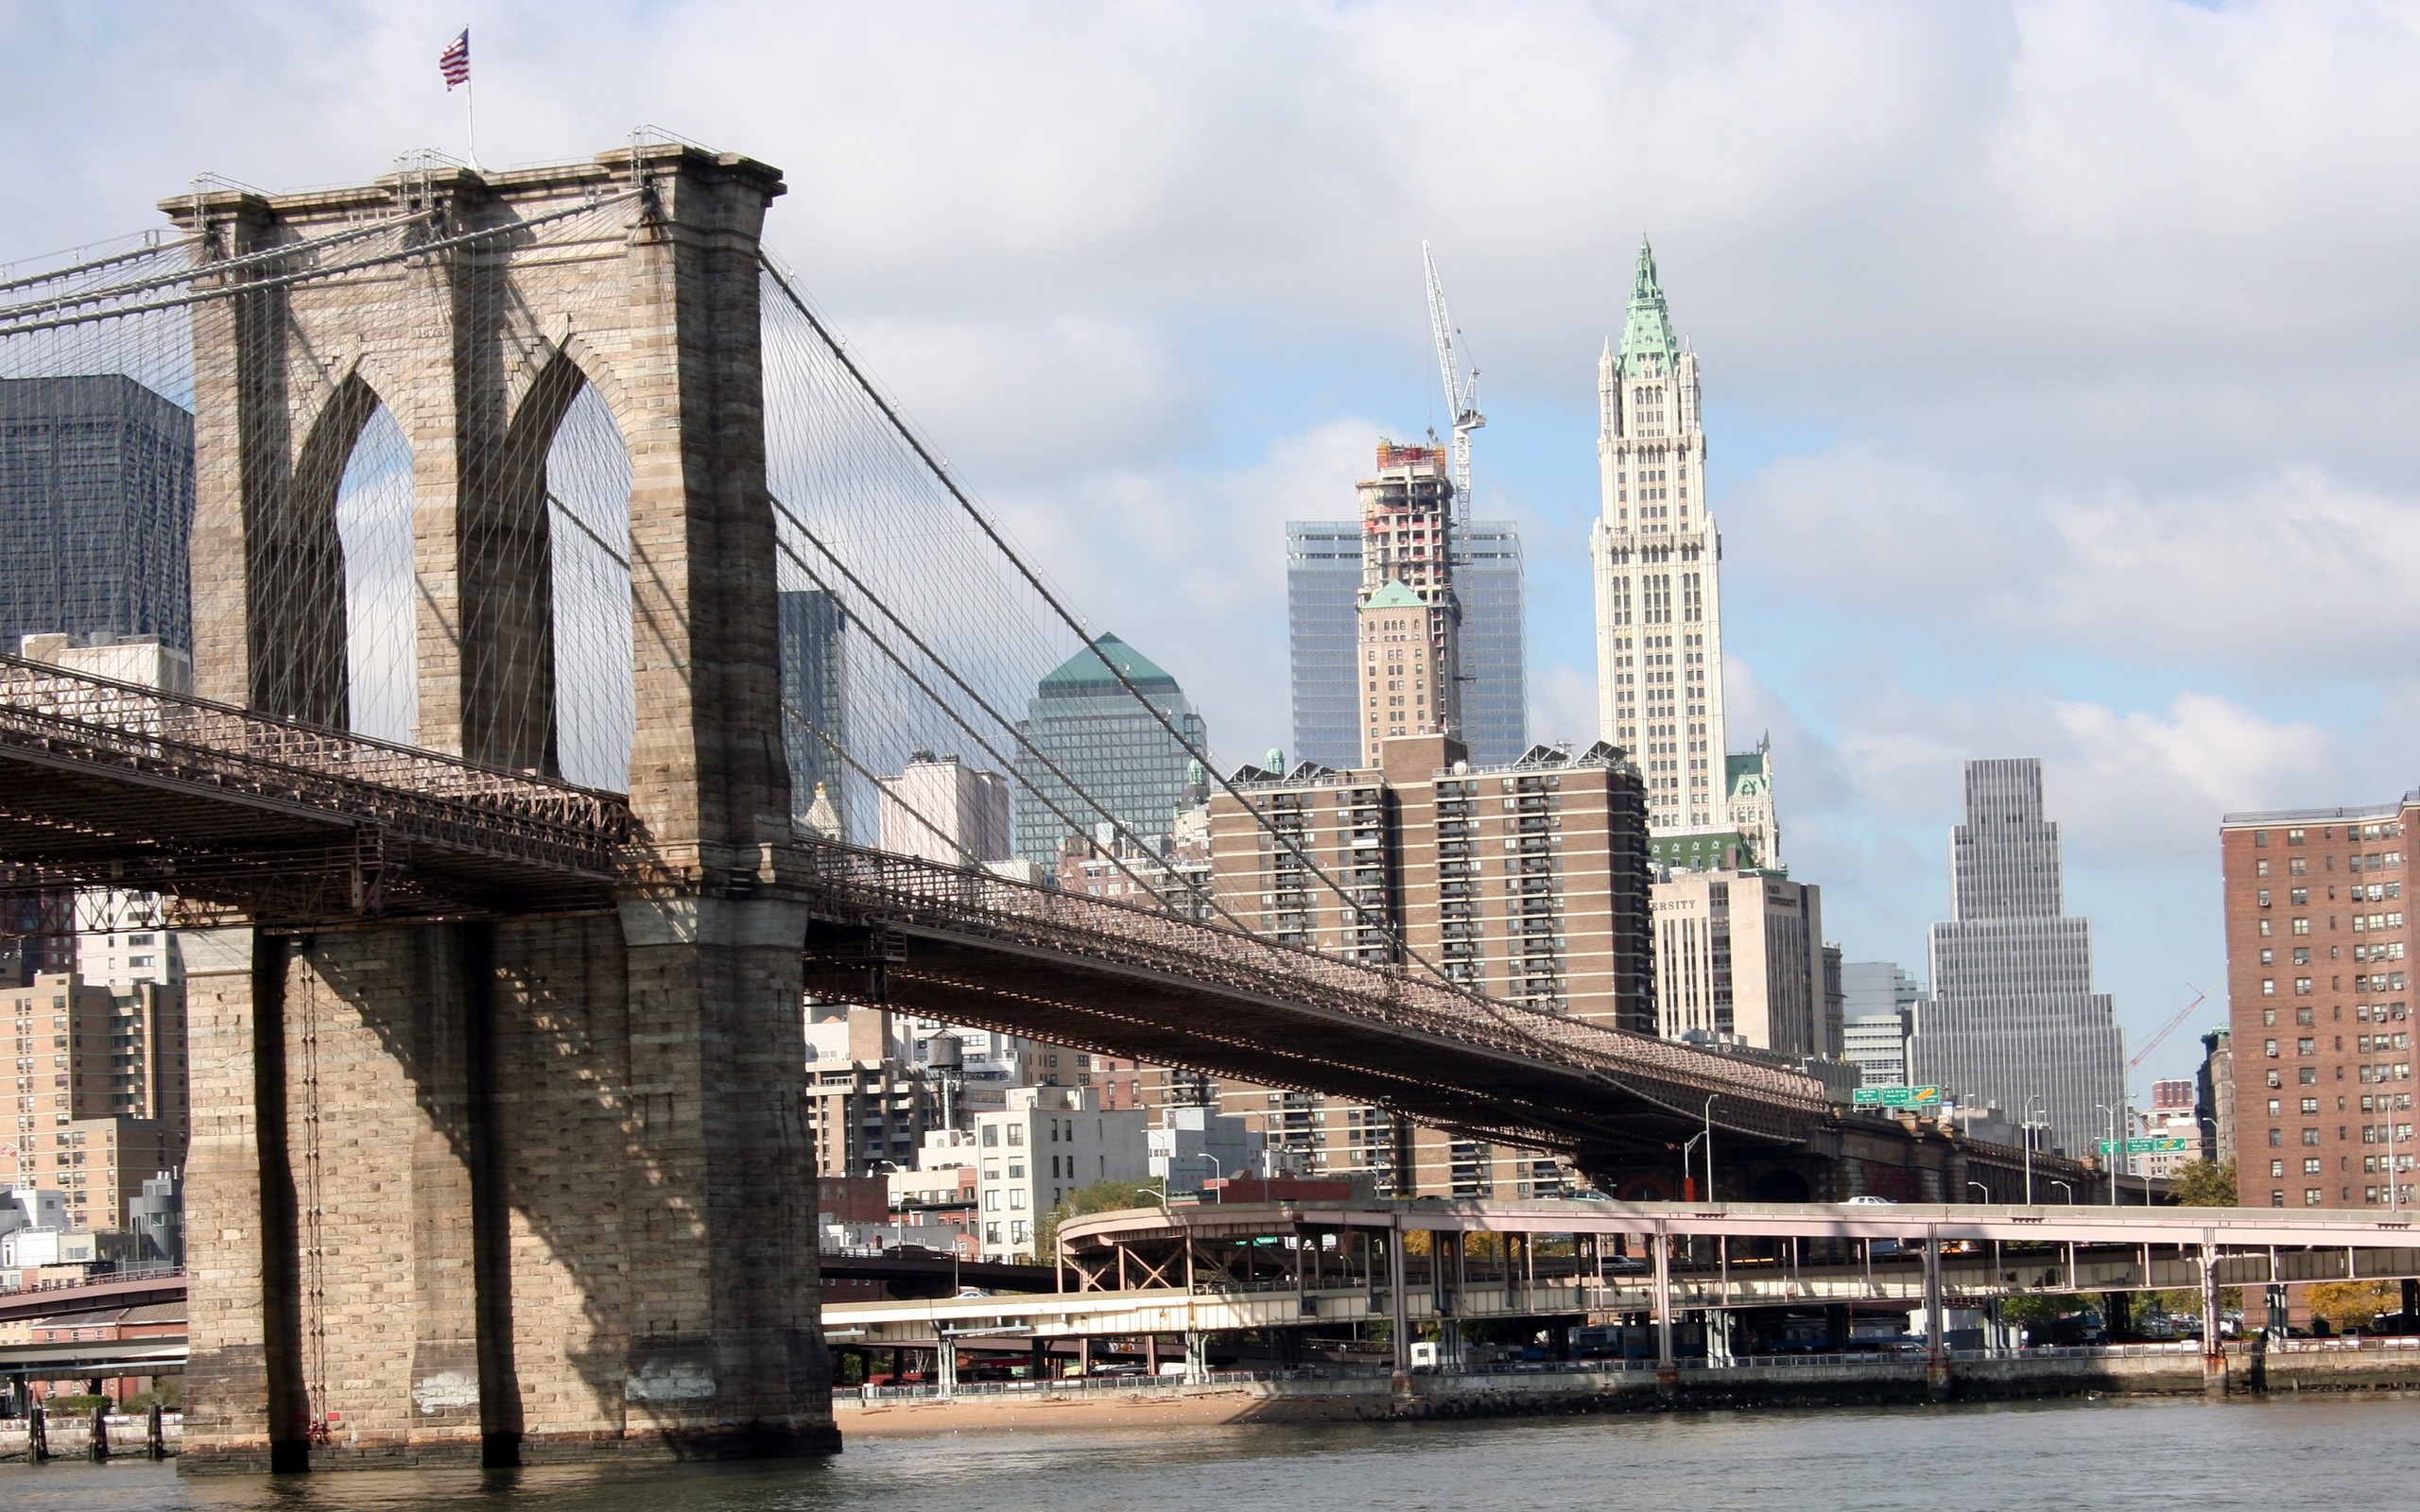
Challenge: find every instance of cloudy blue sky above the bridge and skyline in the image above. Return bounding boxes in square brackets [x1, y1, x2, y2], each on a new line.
[0, 0, 2420, 1096]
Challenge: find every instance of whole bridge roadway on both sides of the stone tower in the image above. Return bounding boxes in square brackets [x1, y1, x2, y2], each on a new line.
[0, 656, 1832, 1168]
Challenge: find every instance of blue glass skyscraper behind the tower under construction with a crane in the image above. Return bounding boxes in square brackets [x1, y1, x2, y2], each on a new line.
[1285, 520, 1530, 767]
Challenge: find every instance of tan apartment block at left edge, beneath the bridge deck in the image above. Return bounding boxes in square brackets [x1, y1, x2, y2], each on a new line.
[0, 975, 191, 1228]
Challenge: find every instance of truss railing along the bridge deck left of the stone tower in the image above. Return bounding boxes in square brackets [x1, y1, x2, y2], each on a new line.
[0, 656, 631, 878]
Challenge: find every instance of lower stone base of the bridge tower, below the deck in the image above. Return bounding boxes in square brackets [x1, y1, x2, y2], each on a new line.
[186, 902, 838, 1469]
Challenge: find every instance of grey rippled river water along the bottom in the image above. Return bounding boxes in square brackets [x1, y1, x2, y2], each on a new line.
[0, 1399, 2420, 1512]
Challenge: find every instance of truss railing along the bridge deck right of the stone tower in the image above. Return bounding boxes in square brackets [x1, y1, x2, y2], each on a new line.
[811, 842, 1827, 1135]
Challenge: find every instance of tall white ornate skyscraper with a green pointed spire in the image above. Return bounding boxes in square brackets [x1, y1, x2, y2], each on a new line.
[1587, 239, 1732, 836]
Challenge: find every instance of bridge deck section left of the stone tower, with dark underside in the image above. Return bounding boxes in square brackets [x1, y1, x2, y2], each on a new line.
[0, 656, 631, 924]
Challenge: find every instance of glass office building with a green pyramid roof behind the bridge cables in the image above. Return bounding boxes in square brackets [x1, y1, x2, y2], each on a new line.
[1016, 634, 1207, 871]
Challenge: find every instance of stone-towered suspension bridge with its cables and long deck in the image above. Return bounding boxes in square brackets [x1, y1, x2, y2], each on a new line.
[0, 140, 2074, 1466]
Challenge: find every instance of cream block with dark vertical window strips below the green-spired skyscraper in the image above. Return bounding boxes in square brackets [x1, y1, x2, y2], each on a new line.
[1652, 871, 1841, 1057]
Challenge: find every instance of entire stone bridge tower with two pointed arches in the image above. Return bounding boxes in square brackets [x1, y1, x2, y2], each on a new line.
[163, 146, 839, 1470]
